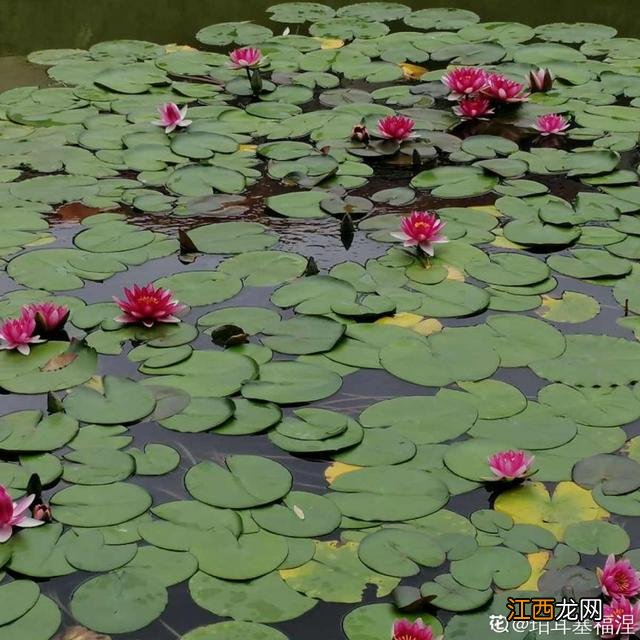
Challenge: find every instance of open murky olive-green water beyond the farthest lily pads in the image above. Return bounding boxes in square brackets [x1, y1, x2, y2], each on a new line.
[0, 0, 640, 56]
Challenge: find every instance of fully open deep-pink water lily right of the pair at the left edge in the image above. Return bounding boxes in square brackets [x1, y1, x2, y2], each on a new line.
[113, 284, 186, 327]
